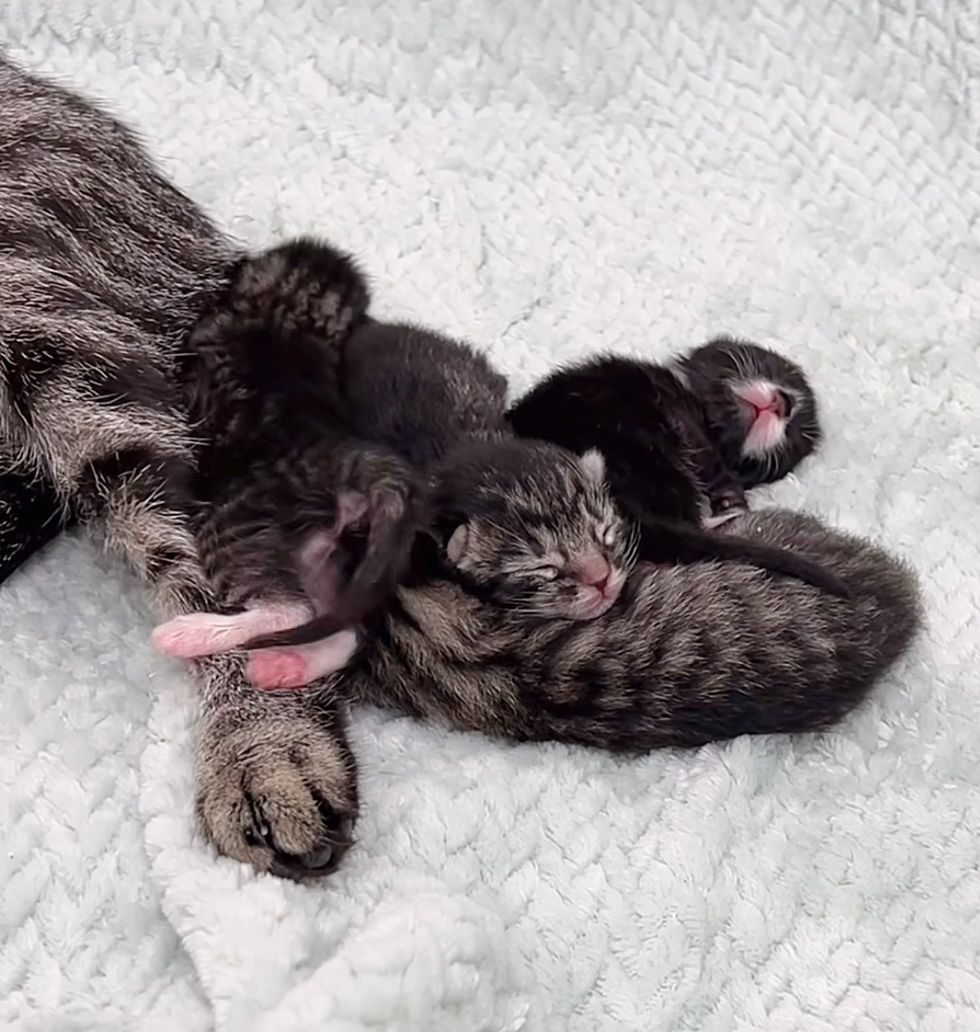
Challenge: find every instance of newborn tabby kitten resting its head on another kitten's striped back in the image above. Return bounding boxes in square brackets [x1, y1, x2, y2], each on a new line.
[238, 322, 632, 668]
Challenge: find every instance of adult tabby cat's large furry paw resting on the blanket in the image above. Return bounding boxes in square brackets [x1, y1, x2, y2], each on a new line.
[197, 696, 357, 880]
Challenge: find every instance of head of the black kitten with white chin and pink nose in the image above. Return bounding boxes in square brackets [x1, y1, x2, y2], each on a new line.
[677, 337, 821, 487]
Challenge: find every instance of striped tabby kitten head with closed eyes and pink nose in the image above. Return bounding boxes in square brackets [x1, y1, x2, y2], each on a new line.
[435, 439, 633, 620]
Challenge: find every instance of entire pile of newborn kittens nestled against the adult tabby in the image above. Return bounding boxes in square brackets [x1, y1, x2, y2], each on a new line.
[145, 240, 919, 829]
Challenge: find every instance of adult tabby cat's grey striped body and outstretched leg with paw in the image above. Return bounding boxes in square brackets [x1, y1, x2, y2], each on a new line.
[0, 57, 367, 874]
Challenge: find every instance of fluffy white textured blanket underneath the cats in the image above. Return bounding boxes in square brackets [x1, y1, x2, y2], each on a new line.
[0, 0, 980, 1032]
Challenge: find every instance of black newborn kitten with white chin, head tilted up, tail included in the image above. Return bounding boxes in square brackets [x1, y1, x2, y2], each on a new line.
[508, 340, 846, 594]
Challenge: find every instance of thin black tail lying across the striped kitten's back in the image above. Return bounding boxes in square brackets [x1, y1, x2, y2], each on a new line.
[640, 519, 850, 599]
